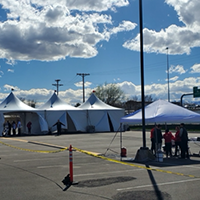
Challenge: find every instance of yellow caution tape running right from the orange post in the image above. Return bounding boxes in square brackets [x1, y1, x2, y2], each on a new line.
[73, 147, 200, 178]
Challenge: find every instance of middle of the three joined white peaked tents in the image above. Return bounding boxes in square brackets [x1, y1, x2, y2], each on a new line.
[38, 93, 86, 132]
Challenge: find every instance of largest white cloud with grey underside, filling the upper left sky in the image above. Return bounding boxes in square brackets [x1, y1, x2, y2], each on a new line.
[0, 0, 135, 61]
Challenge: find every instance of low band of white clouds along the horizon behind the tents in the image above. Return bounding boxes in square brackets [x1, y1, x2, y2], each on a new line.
[0, 77, 200, 107]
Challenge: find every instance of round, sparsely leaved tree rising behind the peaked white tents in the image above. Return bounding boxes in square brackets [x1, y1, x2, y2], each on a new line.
[92, 83, 125, 106]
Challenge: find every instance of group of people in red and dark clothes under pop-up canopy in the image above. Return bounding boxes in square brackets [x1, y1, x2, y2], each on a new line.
[150, 123, 189, 159]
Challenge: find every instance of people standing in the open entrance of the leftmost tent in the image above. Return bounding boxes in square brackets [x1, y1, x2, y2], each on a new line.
[3, 120, 32, 136]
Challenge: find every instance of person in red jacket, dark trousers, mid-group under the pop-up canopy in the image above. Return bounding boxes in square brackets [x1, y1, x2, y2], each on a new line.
[163, 128, 174, 158]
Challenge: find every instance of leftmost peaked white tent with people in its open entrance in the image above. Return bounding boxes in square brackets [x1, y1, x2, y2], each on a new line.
[0, 92, 48, 134]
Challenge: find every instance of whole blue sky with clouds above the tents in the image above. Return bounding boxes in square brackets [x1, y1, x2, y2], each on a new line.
[0, 0, 200, 106]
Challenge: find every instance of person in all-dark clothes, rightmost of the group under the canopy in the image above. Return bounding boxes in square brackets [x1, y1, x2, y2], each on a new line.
[179, 123, 190, 159]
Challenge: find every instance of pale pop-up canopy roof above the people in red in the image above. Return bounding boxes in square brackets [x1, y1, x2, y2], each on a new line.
[120, 100, 200, 124]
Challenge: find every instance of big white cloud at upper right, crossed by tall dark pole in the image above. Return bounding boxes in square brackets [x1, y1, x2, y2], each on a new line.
[123, 0, 200, 55]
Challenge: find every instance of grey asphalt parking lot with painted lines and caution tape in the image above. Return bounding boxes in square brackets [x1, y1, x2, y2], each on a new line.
[0, 131, 200, 200]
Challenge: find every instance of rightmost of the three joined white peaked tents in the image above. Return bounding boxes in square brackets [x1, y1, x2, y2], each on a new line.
[79, 93, 124, 132]
